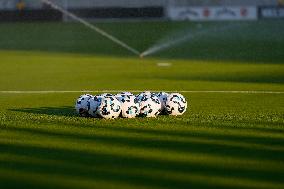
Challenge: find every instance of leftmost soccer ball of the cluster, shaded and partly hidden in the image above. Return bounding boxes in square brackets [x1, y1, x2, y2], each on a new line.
[75, 94, 93, 117]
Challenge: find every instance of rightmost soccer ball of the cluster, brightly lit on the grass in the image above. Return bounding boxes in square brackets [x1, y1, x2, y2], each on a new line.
[166, 93, 187, 116]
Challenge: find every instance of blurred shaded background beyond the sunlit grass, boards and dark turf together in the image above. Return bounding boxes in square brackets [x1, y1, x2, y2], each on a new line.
[0, 0, 284, 62]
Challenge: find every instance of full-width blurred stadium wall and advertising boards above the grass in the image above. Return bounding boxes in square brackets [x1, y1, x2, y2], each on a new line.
[0, 0, 284, 22]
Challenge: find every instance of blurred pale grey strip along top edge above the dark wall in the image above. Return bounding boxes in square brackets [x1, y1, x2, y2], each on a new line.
[0, 0, 280, 10]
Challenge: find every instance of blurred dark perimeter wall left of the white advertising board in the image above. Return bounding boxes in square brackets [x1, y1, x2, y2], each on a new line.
[0, 0, 166, 22]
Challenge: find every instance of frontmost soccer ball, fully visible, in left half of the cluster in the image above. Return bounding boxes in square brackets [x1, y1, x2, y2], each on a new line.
[97, 96, 121, 119]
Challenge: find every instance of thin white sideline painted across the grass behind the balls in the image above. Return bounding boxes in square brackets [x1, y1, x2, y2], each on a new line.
[0, 90, 284, 94]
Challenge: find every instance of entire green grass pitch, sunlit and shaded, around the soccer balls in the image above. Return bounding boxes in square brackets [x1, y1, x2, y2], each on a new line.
[0, 20, 284, 189]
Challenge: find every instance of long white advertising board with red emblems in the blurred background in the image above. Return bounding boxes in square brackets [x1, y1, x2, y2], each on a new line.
[167, 6, 258, 21]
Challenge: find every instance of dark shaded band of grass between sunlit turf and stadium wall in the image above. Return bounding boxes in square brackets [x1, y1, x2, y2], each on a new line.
[0, 20, 284, 64]
